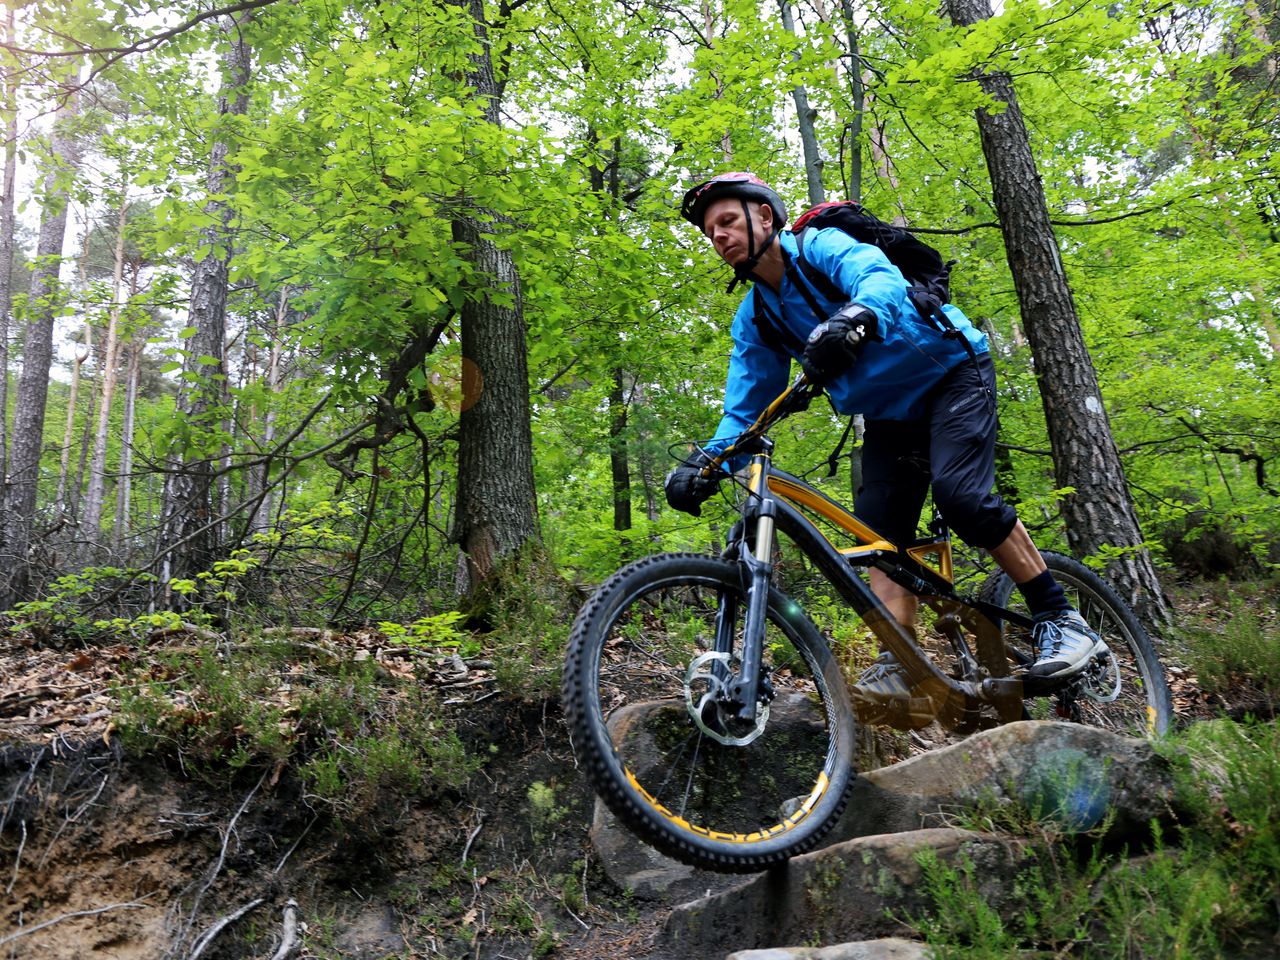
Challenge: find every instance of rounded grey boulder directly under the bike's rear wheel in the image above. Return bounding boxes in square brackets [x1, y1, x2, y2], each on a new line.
[826, 721, 1174, 844]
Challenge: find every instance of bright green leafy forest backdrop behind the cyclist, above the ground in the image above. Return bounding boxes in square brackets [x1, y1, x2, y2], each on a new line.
[0, 0, 1280, 622]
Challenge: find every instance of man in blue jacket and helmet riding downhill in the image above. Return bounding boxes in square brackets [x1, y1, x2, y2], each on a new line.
[666, 173, 1107, 716]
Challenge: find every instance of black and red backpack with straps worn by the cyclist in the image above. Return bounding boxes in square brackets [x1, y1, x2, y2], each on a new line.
[753, 200, 973, 357]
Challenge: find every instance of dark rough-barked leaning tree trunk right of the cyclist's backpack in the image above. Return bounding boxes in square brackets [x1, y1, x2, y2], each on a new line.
[948, 0, 1169, 626]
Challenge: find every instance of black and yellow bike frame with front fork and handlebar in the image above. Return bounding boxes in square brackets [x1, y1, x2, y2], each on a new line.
[713, 376, 1047, 722]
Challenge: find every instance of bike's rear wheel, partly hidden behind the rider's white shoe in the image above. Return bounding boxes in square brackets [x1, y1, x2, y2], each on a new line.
[982, 552, 1174, 737]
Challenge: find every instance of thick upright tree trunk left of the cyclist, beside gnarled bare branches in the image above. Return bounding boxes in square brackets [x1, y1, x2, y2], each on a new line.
[449, 0, 538, 593]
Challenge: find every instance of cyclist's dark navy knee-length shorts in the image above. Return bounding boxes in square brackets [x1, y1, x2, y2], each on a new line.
[855, 353, 1018, 549]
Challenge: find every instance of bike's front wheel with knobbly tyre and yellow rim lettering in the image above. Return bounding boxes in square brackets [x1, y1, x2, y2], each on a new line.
[563, 554, 855, 872]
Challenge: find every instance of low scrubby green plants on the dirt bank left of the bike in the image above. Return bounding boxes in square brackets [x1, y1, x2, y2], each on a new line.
[116, 640, 477, 820]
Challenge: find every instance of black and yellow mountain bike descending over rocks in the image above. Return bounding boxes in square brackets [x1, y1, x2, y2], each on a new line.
[563, 375, 1172, 872]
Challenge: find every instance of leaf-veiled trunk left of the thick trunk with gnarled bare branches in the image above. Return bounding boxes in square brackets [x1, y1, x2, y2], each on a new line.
[160, 20, 252, 593]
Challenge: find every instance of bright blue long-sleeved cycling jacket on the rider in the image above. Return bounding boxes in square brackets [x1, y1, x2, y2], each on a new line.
[707, 227, 987, 463]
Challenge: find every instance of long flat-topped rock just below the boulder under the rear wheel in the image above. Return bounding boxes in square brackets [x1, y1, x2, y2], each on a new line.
[658, 828, 1030, 960]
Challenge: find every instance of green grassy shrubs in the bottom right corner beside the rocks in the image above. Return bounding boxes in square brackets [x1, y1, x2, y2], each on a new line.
[910, 722, 1280, 960]
